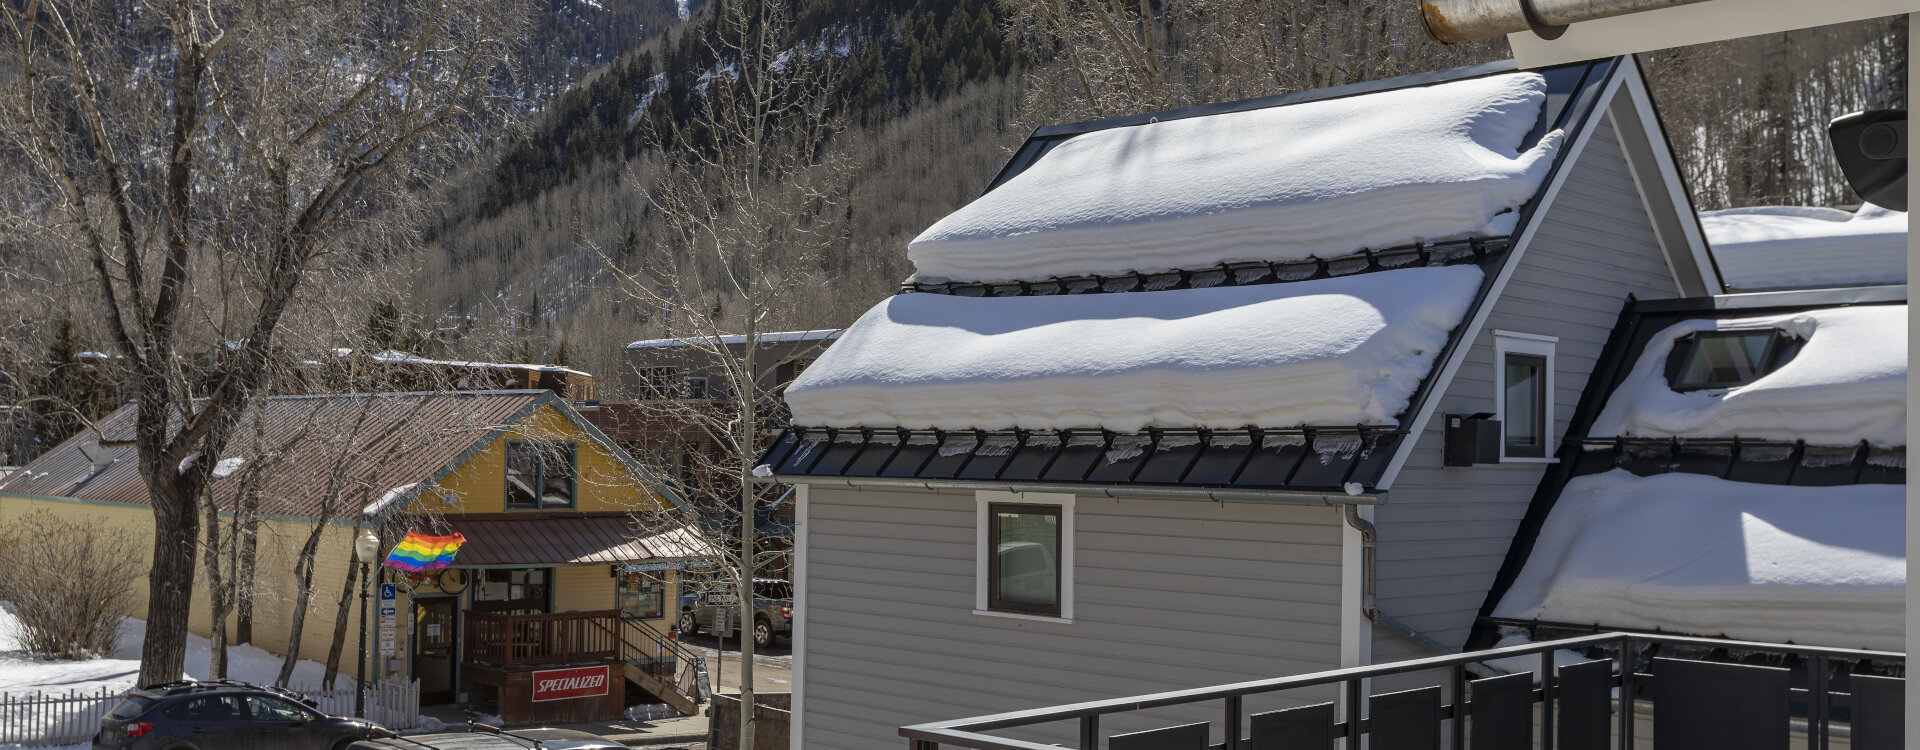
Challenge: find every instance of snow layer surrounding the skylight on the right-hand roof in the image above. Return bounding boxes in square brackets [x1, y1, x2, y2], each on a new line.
[1590, 305, 1907, 445]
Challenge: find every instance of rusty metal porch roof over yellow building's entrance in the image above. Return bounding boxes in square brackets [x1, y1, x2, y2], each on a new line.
[434, 512, 707, 568]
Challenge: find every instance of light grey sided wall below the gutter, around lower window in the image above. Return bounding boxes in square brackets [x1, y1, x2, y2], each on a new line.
[797, 487, 1342, 750]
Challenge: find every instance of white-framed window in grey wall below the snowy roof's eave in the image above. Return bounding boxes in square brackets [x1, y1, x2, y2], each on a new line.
[973, 491, 1073, 621]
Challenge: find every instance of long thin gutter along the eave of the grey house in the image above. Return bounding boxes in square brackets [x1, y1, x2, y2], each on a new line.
[756, 474, 1386, 514]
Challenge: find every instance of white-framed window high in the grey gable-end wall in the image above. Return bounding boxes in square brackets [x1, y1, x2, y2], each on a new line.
[1494, 330, 1559, 462]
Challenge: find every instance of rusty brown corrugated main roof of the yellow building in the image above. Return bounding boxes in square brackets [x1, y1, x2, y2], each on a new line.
[0, 389, 678, 520]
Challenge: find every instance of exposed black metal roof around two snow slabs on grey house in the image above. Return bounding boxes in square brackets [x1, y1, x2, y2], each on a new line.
[760, 58, 1626, 495]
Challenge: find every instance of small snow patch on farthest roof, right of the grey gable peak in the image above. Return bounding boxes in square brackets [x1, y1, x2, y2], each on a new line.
[1699, 203, 1907, 292]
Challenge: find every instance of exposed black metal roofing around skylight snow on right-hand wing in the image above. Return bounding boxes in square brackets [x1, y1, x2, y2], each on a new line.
[1467, 286, 1907, 648]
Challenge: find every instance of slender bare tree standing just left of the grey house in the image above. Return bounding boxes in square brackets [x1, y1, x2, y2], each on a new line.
[603, 2, 845, 746]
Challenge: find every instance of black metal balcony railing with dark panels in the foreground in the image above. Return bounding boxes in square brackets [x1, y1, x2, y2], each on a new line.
[900, 633, 1907, 750]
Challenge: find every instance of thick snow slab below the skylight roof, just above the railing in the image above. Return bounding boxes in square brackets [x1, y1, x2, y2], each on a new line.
[1494, 470, 1907, 650]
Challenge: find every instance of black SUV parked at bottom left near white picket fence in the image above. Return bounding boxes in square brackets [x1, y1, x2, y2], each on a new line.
[94, 679, 394, 750]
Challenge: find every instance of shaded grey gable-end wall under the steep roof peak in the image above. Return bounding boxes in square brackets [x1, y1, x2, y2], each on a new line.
[1373, 115, 1676, 662]
